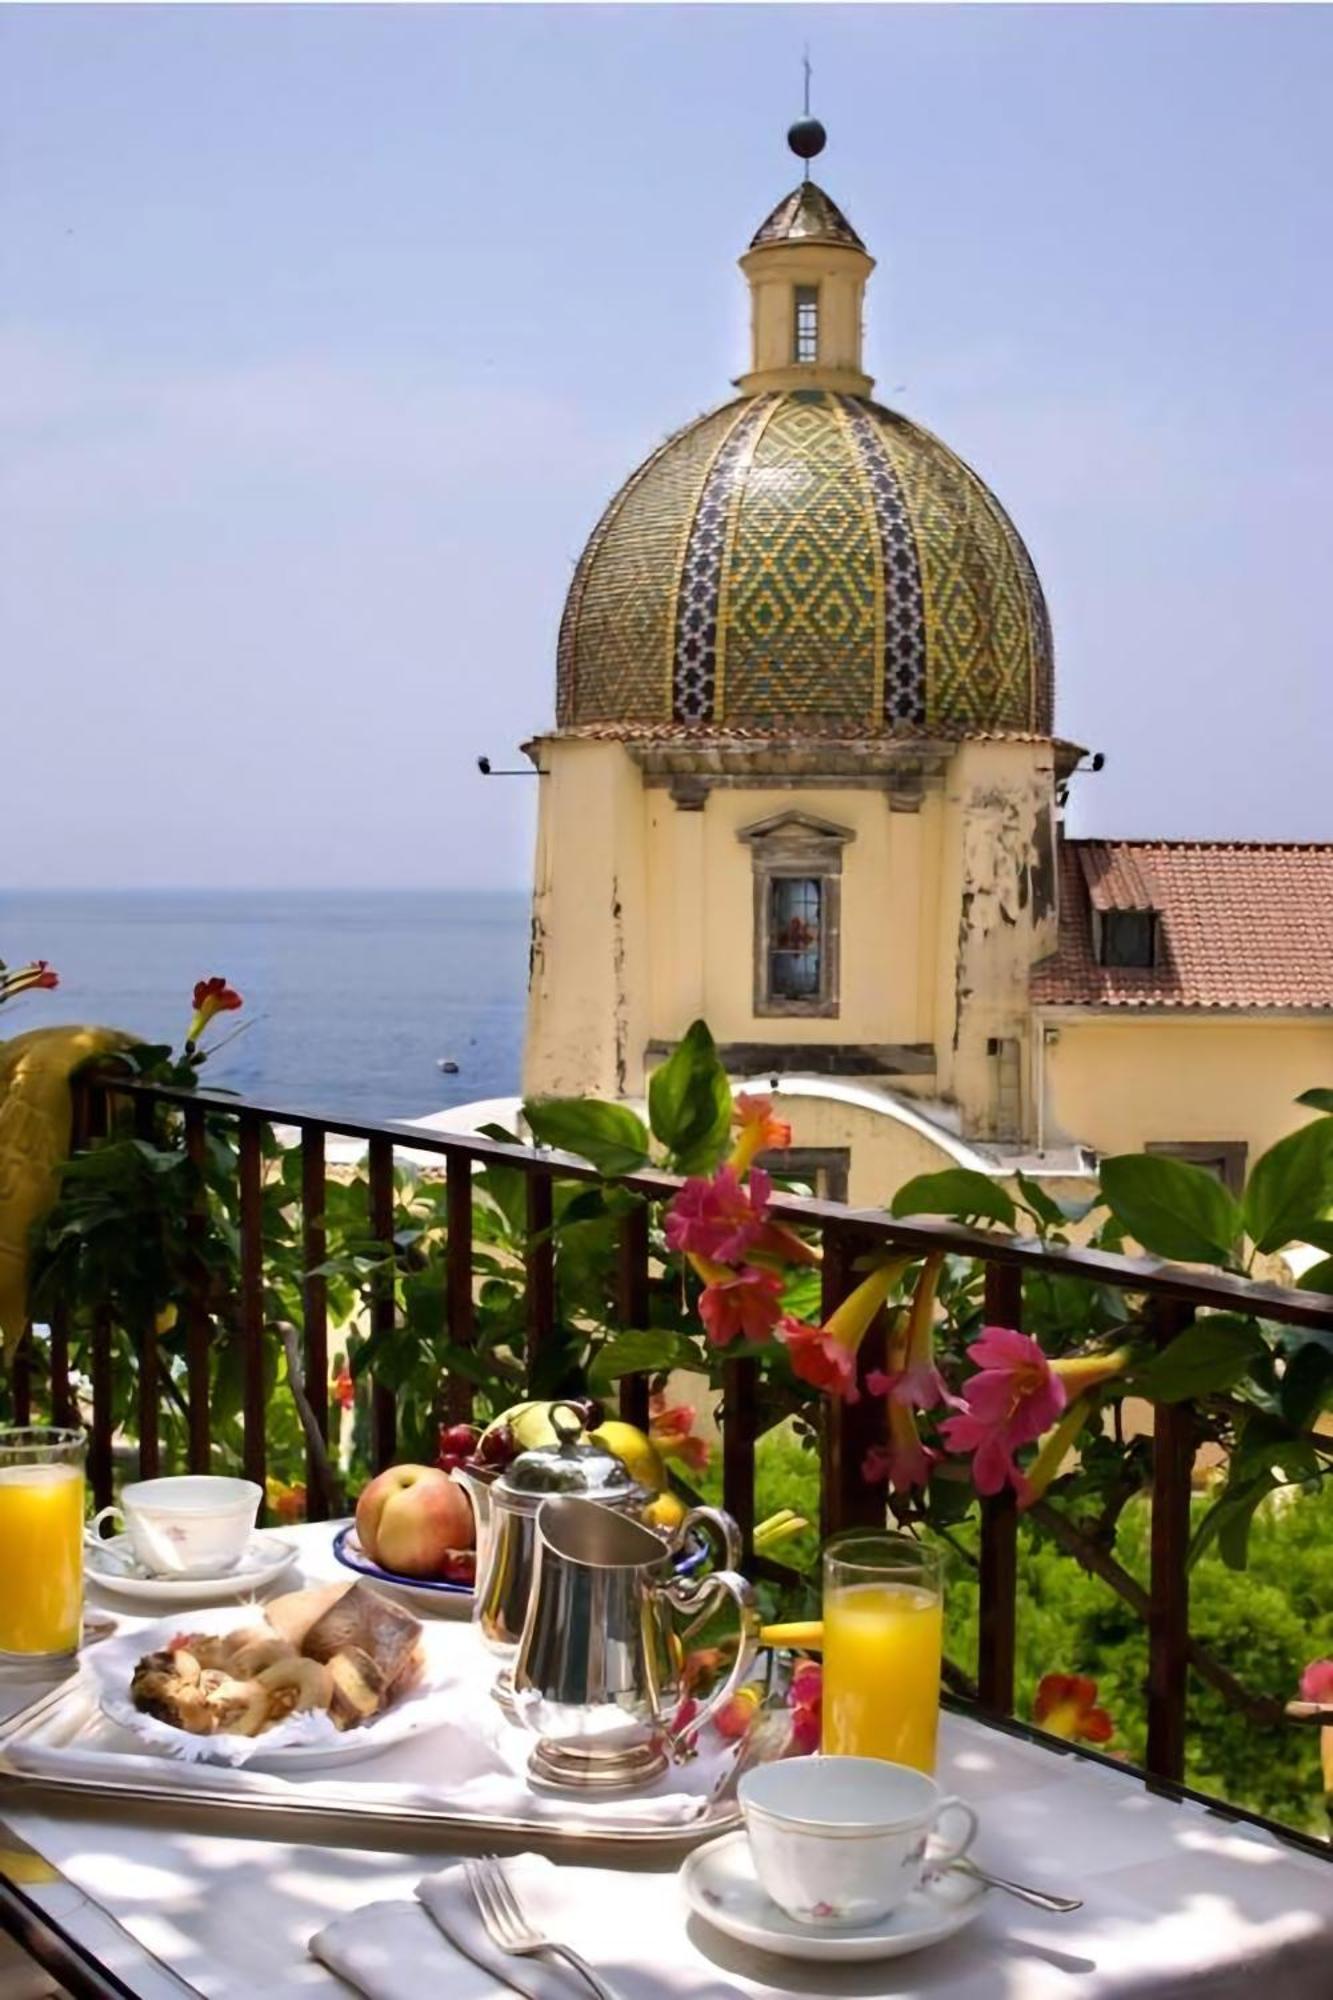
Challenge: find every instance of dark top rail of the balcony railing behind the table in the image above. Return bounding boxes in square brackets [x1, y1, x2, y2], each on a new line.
[104, 1078, 1333, 1328]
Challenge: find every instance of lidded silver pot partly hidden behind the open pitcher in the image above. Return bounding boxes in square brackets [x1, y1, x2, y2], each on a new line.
[452, 1402, 650, 1672]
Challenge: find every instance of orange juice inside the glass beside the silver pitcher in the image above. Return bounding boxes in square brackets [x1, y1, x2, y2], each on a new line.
[823, 1582, 943, 1772]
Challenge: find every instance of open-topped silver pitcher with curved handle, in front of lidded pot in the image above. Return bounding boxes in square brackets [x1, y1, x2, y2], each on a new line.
[512, 1498, 759, 1792]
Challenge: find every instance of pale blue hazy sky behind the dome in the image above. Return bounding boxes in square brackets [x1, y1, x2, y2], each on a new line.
[0, 4, 1333, 888]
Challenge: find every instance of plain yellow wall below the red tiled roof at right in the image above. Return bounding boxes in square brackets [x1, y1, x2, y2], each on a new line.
[1045, 1014, 1333, 1166]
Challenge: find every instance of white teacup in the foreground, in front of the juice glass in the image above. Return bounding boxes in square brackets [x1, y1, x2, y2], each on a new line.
[739, 1756, 977, 1930]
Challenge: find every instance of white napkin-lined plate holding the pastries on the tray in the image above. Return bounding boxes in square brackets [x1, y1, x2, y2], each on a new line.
[82, 1606, 458, 1776]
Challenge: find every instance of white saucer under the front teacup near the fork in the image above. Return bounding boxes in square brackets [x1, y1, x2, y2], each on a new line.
[681, 1832, 987, 1964]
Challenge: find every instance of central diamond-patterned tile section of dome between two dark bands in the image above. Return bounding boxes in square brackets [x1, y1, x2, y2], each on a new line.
[717, 390, 883, 732]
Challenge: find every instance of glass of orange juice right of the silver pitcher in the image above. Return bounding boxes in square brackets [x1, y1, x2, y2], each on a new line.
[823, 1528, 945, 1772]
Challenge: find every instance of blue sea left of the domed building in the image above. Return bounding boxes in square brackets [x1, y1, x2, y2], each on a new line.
[0, 890, 528, 1118]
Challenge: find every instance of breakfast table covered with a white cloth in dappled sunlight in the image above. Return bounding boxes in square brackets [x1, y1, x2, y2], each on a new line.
[0, 1526, 1333, 2000]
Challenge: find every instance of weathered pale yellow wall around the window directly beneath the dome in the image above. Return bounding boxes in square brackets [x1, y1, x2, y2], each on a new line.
[524, 738, 1053, 1136]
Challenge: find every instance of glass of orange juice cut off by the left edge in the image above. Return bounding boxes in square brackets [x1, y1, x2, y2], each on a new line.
[0, 1426, 84, 1664]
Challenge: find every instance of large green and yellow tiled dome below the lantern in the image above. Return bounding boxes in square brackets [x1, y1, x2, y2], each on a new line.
[556, 388, 1053, 738]
